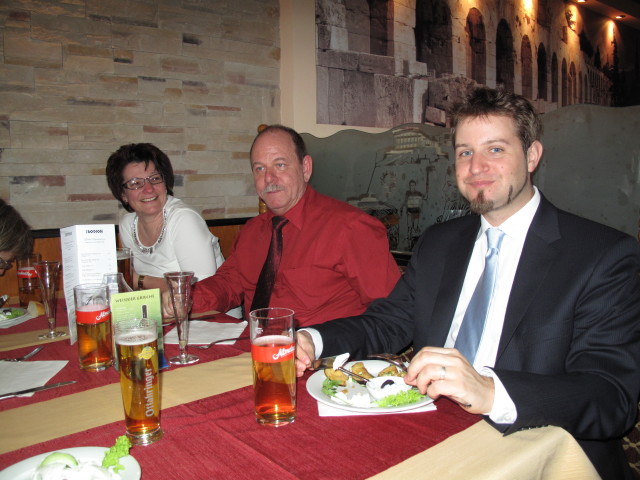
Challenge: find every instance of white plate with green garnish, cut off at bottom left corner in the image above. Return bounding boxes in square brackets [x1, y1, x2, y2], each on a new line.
[0, 435, 142, 480]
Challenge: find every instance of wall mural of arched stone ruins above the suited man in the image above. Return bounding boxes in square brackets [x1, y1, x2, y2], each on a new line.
[316, 0, 640, 128]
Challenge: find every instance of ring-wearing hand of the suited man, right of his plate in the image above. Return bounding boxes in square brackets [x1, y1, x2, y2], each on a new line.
[405, 347, 495, 414]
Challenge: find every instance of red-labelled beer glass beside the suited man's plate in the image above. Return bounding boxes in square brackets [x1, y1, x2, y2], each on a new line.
[249, 308, 296, 427]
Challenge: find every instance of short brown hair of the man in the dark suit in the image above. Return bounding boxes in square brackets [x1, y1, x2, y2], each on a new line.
[450, 88, 542, 153]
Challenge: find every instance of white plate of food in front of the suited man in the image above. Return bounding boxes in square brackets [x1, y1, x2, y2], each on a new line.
[307, 360, 433, 413]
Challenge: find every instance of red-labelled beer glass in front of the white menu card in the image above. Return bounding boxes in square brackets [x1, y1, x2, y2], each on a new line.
[73, 283, 113, 372]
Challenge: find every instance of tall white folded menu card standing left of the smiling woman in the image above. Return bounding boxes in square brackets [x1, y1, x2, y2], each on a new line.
[60, 224, 118, 344]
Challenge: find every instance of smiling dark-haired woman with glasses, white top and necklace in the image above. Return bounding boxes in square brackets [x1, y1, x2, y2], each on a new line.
[106, 143, 240, 316]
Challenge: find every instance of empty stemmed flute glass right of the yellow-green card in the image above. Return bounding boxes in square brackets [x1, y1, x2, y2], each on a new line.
[164, 272, 200, 365]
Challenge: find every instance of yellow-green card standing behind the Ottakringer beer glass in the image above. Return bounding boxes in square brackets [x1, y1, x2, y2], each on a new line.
[111, 288, 169, 370]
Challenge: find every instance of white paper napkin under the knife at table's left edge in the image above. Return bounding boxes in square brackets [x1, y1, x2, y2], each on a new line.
[0, 360, 69, 397]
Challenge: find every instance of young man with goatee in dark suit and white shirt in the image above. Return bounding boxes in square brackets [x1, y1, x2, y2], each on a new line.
[297, 89, 640, 479]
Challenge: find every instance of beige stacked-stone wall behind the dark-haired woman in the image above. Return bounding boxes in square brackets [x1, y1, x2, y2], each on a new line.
[0, 0, 280, 229]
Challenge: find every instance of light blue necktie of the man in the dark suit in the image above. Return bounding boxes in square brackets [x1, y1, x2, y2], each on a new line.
[455, 228, 504, 364]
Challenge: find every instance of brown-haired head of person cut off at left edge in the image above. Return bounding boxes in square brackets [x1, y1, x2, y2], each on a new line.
[0, 198, 33, 277]
